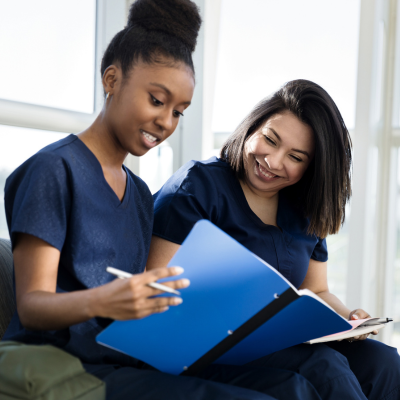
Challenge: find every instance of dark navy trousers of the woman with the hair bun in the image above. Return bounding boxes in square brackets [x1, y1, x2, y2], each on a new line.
[84, 364, 321, 400]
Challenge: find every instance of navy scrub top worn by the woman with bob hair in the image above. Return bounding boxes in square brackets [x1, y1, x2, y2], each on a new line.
[153, 157, 328, 288]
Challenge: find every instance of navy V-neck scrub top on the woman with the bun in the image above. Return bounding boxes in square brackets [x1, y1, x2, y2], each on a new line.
[3, 135, 153, 365]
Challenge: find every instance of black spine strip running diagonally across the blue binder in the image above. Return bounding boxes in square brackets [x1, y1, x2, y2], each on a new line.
[180, 288, 299, 376]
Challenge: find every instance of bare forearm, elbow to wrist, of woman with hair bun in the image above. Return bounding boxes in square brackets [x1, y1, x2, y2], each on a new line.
[18, 289, 96, 330]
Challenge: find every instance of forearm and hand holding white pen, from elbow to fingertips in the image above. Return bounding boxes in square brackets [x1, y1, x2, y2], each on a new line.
[17, 268, 190, 330]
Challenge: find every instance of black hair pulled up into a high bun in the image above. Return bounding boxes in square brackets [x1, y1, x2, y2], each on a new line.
[101, 0, 201, 82]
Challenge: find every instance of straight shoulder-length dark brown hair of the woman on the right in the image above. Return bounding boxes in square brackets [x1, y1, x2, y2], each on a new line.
[220, 79, 352, 238]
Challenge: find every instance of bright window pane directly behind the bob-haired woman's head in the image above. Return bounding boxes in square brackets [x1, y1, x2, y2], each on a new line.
[213, 0, 360, 132]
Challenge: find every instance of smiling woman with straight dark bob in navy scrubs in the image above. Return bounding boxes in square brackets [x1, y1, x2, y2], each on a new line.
[147, 80, 400, 400]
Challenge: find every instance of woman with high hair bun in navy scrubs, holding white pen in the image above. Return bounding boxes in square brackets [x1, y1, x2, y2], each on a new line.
[3, 0, 319, 400]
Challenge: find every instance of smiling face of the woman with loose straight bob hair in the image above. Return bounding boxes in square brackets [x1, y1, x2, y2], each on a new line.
[244, 111, 315, 197]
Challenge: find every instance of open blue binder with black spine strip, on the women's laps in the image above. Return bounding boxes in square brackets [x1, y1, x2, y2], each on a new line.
[97, 220, 351, 375]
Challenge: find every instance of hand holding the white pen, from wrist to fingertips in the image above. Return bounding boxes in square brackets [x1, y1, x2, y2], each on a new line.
[90, 267, 190, 320]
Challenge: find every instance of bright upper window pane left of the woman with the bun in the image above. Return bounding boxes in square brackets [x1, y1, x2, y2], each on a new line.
[0, 0, 96, 113]
